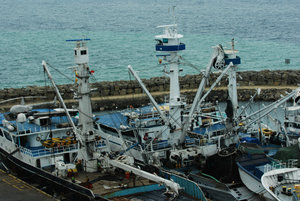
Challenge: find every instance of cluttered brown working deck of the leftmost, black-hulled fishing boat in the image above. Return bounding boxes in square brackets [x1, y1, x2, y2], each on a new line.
[68, 169, 204, 201]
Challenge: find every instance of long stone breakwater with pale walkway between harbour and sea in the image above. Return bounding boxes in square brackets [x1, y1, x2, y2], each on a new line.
[0, 70, 300, 111]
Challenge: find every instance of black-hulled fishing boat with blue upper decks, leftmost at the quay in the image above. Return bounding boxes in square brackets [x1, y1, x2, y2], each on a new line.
[0, 39, 206, 200]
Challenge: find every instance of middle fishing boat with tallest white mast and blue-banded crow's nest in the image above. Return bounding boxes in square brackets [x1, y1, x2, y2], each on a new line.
[96, 20, 240, 171]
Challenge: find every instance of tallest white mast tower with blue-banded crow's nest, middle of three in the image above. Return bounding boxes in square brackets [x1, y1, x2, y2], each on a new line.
[155, 7, 185, 138]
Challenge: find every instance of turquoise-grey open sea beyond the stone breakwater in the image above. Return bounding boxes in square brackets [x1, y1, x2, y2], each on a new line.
[0, 0, 300, 88]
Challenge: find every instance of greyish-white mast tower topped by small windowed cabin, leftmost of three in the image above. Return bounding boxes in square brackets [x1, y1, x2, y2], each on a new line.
[67, 39, 97, 172]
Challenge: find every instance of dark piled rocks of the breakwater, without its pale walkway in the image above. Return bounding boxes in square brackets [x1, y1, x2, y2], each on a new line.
[0, 70, 300, 110]
